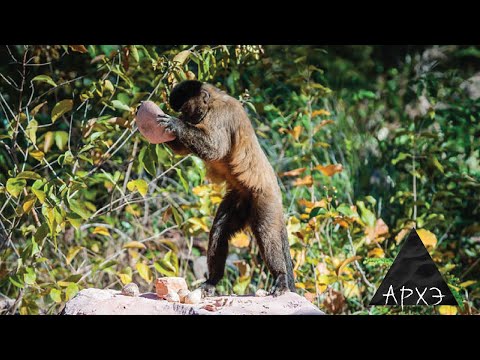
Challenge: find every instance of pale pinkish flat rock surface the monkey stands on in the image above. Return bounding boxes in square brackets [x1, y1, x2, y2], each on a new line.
[62, 288, 323, 315]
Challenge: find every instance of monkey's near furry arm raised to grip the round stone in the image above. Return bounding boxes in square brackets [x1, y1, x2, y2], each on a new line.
[158, 115, 230, 161]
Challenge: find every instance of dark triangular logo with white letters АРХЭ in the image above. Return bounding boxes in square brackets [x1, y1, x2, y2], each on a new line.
[370, 229, 458, 306]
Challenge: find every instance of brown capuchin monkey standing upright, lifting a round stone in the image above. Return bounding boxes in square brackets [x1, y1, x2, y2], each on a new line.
[157, 80, 295, 296]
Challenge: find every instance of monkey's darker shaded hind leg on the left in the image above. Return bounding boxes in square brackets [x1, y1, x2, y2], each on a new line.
[202, 191, 249, 296]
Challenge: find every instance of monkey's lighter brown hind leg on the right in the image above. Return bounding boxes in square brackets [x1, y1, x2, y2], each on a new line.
[250, 198, 294, 296]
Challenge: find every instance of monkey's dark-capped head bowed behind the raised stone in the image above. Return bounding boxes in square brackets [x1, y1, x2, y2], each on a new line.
[170, 80, 210, 124]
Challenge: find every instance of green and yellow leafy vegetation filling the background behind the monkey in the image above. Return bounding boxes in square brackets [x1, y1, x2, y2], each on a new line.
[0, 45, 480, 314]
